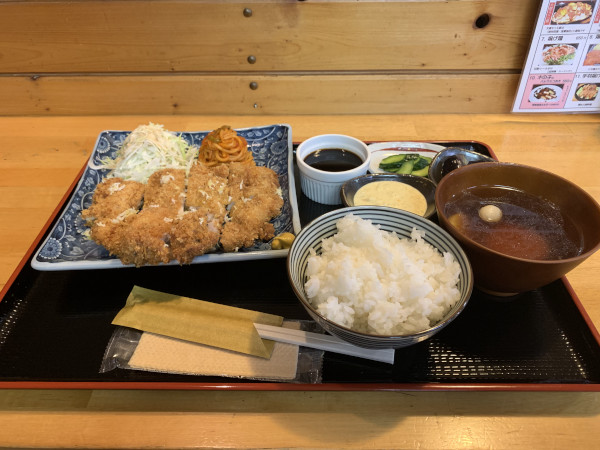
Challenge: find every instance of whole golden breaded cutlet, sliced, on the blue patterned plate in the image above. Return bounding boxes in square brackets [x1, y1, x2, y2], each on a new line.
[86, 158, 283, 267]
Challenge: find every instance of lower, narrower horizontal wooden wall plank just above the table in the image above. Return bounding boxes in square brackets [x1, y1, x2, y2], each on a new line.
[0, 74, 519, 115]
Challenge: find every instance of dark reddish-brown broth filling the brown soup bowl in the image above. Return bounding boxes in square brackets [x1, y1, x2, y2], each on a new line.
[444, 186, 583, 260]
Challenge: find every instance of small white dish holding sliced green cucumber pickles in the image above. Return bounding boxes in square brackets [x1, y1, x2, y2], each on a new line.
[368, 142, 446, 176]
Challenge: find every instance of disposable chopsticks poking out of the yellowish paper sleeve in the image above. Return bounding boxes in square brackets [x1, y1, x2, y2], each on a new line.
[254, 323, 394, 364]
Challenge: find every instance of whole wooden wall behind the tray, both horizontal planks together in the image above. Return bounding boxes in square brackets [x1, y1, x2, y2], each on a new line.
[0, 0, 539, 116]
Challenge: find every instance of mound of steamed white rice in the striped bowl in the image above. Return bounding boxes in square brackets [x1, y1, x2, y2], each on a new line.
[304, 214, 460, 335]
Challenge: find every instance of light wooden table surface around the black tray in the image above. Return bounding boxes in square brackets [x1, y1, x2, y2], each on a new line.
[0, 114, 600, 449]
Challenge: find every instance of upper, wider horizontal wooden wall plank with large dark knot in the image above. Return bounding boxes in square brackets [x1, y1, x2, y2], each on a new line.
[0, 0, 539, 74]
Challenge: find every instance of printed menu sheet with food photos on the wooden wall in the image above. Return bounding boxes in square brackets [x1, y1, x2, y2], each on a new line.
[513, 0, 600, 113]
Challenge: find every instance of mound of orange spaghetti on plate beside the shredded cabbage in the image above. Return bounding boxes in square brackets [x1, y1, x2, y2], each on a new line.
[198, 125, 254, 167]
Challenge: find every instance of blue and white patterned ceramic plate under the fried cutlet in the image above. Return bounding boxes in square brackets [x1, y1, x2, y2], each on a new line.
[31, 124, 300, 270]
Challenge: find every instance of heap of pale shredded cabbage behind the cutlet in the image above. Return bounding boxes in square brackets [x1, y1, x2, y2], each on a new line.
[103, 123, 198, 183]
